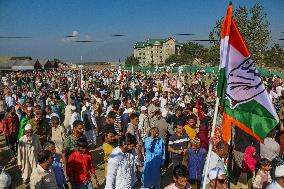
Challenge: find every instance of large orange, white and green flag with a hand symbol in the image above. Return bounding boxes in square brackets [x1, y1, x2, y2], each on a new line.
[217, 5, 279, 141]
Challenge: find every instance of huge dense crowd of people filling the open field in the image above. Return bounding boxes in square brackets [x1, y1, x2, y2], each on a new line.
[0, 69, 284, 189]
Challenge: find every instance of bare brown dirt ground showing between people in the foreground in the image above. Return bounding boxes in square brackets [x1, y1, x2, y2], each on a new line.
[0, 135, 172, 189]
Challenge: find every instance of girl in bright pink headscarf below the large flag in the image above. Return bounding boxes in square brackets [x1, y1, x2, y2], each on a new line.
[242, 146, 257, 173]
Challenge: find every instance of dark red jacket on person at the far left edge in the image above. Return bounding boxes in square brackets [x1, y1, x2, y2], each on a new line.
[1, 114, 20, 135]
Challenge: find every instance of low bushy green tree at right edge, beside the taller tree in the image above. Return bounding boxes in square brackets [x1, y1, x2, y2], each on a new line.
[264, 44, 284, 69]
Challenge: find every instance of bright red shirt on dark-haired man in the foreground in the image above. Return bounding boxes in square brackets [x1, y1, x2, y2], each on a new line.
[67, 151, 95, 186]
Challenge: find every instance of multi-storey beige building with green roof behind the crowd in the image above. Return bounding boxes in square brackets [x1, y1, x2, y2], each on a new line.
[134, 37, 182, 66]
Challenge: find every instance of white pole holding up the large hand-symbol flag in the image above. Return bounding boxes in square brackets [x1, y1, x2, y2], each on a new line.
[202, 97, 220, 189]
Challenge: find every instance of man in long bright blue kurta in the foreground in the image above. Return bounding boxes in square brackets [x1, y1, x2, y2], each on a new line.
[142, 127, 166, 189]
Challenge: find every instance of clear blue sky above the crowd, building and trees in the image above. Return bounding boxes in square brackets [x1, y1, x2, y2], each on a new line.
[0, 0, 284, 62]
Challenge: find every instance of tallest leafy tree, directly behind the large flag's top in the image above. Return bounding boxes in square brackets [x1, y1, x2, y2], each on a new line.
[209, 3, 271, 64]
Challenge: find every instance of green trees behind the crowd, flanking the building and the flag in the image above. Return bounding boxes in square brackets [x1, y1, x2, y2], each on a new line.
[125, 4, 284, 68]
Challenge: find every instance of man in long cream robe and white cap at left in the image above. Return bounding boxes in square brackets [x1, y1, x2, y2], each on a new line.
[17, 124, 41, 185]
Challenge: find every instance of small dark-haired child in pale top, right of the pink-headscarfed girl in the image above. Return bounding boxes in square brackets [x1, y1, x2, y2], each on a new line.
[253, 158, 271, 189]
